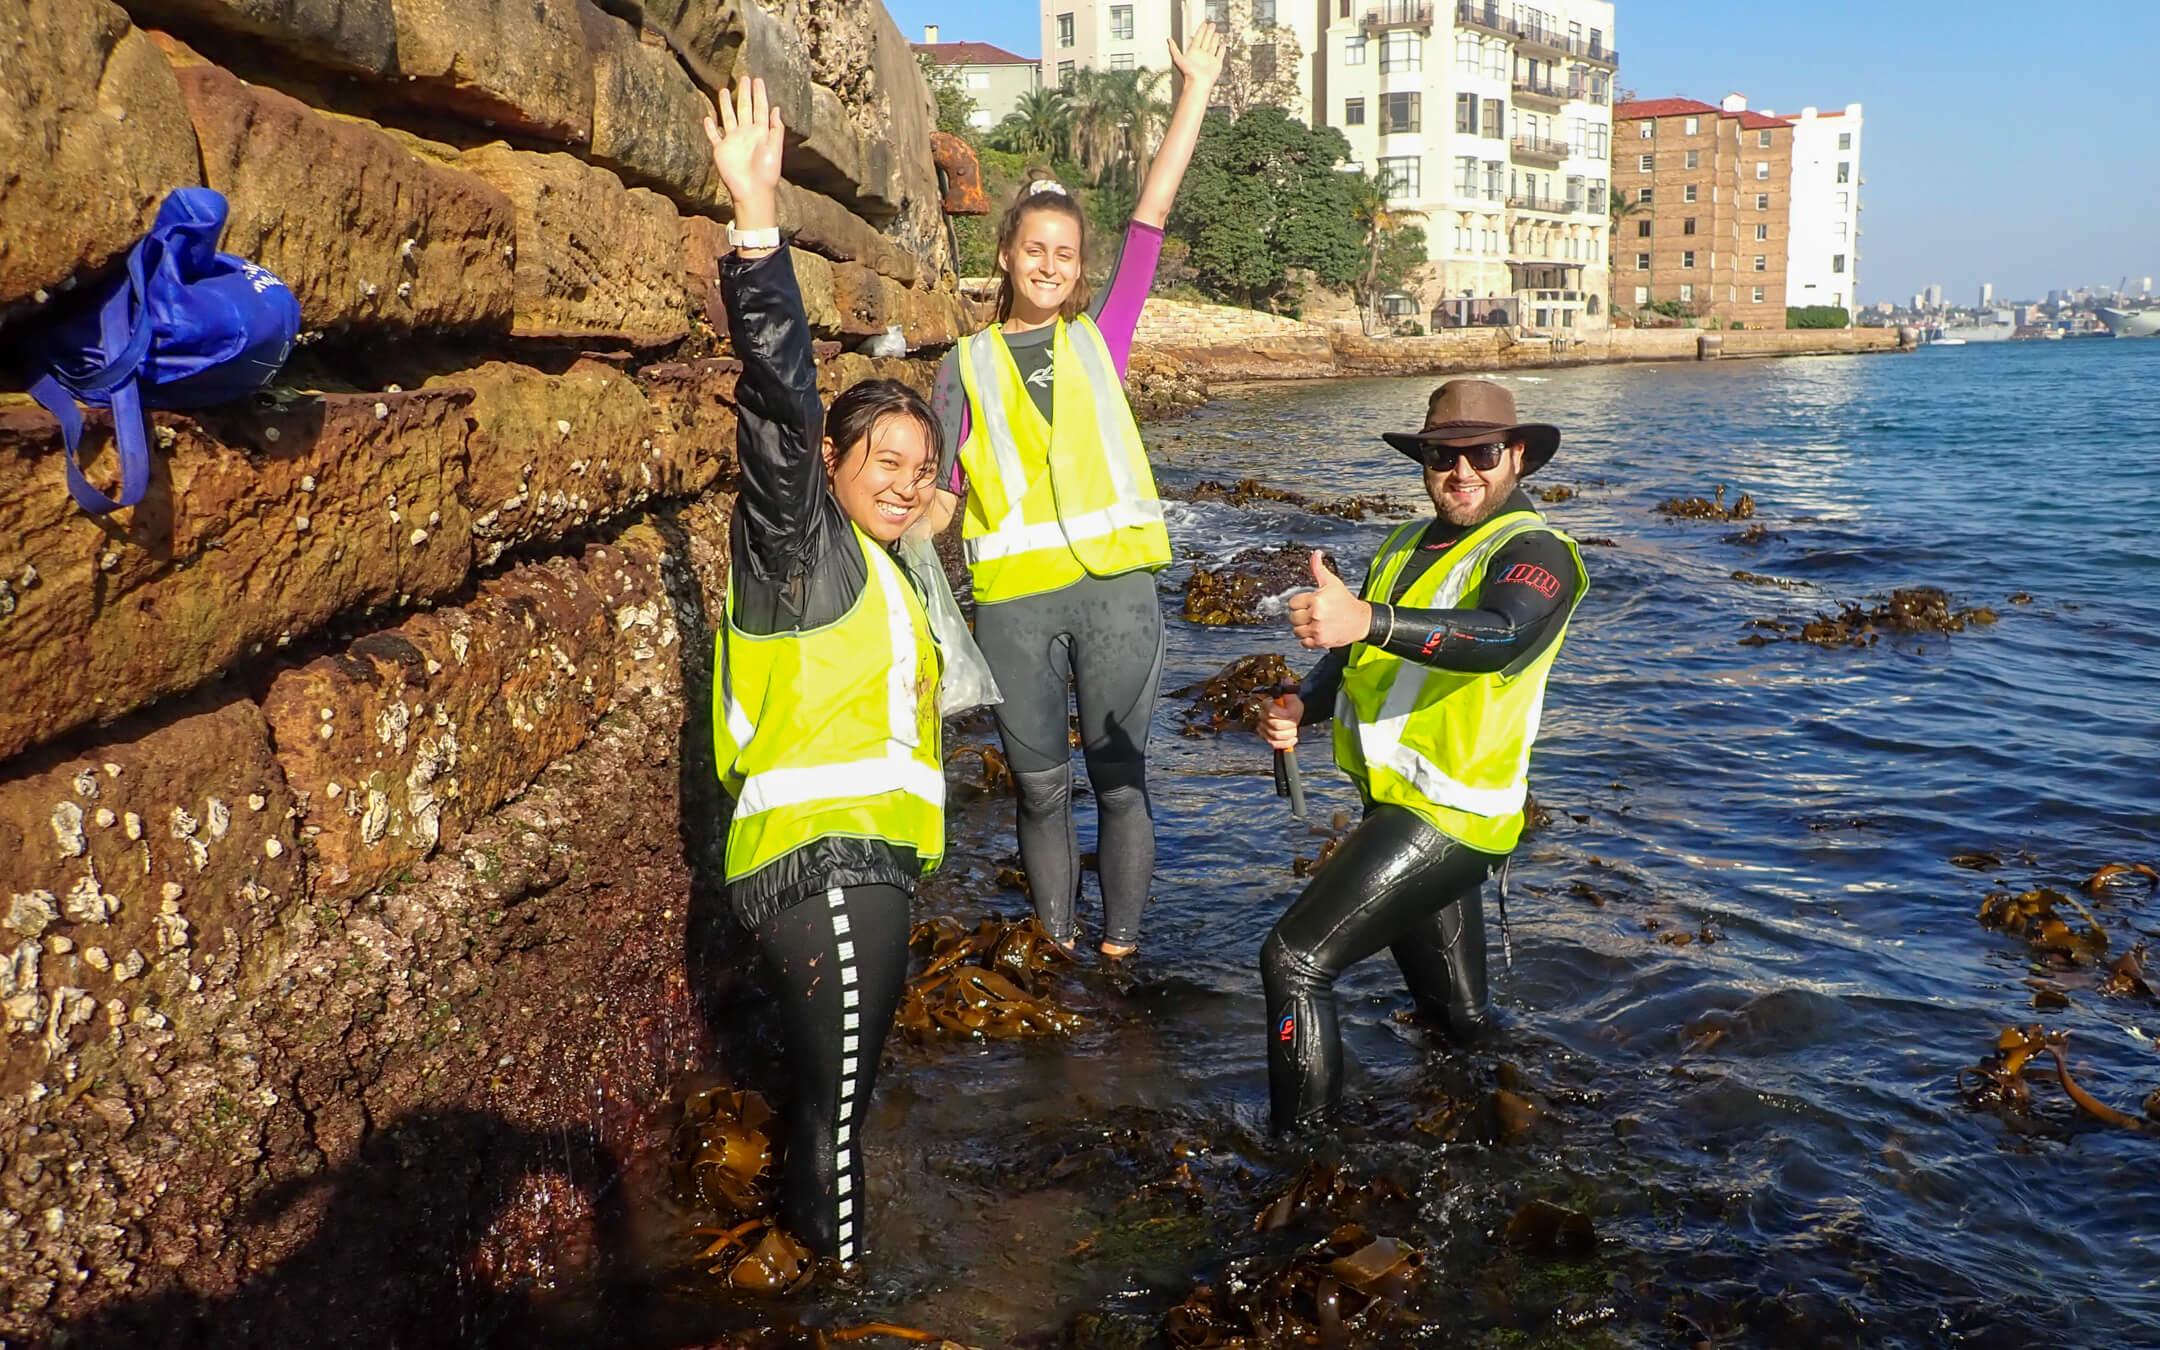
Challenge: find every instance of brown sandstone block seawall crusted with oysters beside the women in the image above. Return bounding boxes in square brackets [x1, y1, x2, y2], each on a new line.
[0, 0, 989, 1344]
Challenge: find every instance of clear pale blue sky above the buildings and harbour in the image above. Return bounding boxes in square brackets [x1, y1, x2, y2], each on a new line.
[886, 0, 2160, 305]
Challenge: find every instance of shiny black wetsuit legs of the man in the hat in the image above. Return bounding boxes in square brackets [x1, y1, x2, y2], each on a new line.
[1259, 806, 1499, 1132]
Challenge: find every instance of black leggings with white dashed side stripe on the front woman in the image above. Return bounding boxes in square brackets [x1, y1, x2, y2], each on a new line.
[756, 886, 907, 1261]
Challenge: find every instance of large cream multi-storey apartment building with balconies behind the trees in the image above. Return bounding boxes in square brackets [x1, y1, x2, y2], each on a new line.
[1043, 0, 1618, 335]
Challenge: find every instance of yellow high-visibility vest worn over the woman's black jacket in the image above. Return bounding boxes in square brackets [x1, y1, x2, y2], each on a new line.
[713, 527, 944, 881]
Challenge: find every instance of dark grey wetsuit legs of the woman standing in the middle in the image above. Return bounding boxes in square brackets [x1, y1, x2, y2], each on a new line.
[974, 572, 1162, 946]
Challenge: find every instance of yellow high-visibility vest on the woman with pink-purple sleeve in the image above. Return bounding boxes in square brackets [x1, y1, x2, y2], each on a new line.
[957, 315, 1171, 605]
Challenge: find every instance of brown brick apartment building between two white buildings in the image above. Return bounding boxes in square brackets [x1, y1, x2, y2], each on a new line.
[1611, 95, 1793, 328]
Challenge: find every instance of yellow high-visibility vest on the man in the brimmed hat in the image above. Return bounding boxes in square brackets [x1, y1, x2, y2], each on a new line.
[1335, 512, 1590, 853]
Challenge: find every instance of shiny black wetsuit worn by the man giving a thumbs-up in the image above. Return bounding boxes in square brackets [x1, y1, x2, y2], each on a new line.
[1259, 490, 1577, 1130]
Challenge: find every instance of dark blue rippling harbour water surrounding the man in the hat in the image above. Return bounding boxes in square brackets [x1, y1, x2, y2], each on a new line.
[630, 341, 2160, 1346]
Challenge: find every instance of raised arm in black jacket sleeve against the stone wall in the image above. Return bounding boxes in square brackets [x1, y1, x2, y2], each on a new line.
[704, 80, 825, 579]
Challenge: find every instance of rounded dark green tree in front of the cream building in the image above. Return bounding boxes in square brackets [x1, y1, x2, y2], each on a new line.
[1171, 106, 1365, 309]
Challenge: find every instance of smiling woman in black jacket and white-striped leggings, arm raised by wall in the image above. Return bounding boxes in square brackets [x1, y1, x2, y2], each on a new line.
[706, 80, 944, 1264]
